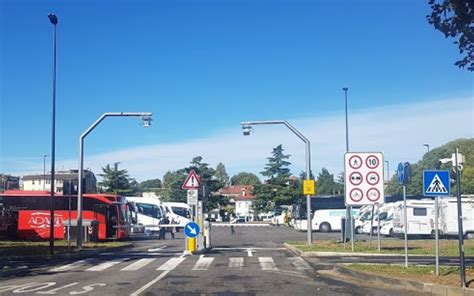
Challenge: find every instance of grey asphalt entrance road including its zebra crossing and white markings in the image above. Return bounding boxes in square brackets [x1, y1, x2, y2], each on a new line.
[0, 227, 430, 296]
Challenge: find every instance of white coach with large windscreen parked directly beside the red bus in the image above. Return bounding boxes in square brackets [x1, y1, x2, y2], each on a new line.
[126, 196, 165, 233]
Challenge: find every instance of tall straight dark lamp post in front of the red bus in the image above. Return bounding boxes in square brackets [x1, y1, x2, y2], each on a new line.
[48, 13, 58, 254]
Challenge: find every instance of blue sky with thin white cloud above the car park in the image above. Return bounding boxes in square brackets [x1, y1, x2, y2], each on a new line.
[0, 0, 474, 180]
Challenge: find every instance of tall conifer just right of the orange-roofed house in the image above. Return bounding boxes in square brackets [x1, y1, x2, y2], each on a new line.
[261, 144, 291, 185]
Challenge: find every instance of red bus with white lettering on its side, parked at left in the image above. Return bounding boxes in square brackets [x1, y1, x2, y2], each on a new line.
[0, 190, 131, 240]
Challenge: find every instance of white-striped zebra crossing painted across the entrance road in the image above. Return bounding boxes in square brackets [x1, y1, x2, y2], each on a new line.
[49, 255, 312, 273]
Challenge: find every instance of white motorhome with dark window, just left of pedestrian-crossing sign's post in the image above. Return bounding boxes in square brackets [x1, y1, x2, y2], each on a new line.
[392, 199, 435, 235]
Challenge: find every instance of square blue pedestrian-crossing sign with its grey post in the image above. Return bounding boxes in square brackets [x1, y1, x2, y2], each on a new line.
[423, 171, 451, 276]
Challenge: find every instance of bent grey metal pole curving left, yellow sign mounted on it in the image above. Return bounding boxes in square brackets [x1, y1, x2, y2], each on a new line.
[240, 120, 313, 245]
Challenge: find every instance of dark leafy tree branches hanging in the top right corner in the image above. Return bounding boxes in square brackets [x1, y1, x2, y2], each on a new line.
[426, 0, 474, 71]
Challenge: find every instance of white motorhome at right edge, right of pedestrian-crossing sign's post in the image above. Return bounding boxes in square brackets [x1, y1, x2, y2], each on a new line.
[438, 197, 474, 238]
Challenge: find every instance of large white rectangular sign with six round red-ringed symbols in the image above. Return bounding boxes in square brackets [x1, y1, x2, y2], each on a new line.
[344, 152, 384, 206]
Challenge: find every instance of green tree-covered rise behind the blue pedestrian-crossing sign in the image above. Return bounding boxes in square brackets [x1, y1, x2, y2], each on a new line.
[386, 138, 474, 195]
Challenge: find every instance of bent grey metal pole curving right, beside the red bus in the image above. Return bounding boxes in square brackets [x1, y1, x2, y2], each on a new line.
[77, 112, 153, 249]
